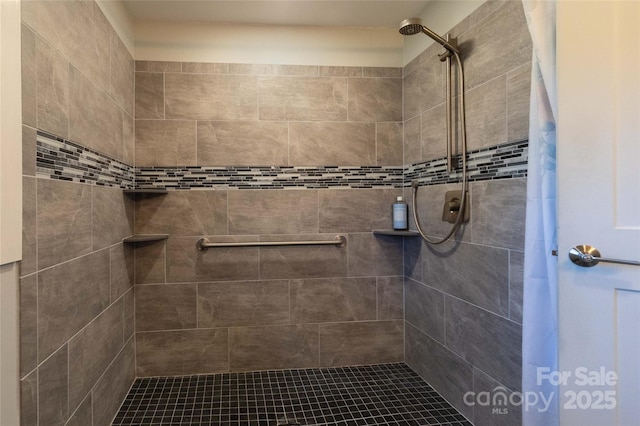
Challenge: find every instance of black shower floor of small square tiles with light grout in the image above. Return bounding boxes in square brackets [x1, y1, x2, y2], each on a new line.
[112, 363, 471, 426]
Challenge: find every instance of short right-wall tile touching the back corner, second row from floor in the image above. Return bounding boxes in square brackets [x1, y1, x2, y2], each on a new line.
[404, 279, 445, 344]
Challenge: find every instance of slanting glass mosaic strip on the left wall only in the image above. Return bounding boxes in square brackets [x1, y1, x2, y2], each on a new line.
[36, 130, 134, 189]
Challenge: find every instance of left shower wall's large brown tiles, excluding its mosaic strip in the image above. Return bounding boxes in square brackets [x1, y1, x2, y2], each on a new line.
[20, 1, 135, 425]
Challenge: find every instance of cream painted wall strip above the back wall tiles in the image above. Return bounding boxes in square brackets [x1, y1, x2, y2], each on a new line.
[135, 21, 403, 67]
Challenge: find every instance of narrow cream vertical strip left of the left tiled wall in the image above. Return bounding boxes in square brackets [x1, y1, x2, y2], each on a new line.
[0, 0, 22, 425]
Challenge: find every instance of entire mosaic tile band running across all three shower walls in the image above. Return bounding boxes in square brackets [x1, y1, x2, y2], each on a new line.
[36, 131, 528, 190]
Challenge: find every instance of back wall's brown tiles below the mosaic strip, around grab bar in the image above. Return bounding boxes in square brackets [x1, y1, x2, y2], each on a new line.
[135, 189, 403, 376]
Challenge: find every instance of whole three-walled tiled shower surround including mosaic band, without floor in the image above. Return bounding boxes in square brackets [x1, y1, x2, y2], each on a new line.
[21, 1, 531, 425]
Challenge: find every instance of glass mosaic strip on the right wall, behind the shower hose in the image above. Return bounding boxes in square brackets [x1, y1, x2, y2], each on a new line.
[404, 141, 529, 186]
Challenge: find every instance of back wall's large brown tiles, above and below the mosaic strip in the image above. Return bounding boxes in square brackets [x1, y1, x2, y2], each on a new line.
[135, 61, 403, 375]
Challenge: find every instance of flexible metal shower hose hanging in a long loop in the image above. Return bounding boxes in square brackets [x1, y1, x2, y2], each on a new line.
[411, 49, 468, 245]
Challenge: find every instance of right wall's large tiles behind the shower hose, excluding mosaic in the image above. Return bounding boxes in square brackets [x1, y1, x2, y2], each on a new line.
[404, 1, 532, 425]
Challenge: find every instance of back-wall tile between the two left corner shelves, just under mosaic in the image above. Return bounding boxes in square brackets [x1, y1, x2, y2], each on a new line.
[135, 190, 227, 236]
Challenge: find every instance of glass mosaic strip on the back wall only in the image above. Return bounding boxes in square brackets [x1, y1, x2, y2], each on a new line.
[135, 166, 404, 189]
